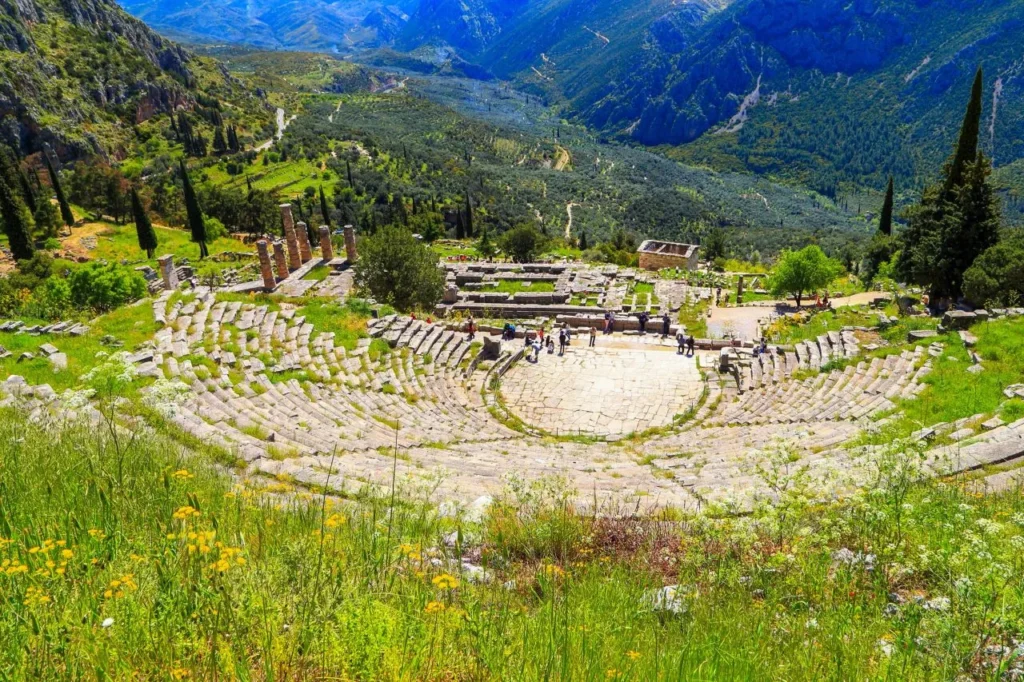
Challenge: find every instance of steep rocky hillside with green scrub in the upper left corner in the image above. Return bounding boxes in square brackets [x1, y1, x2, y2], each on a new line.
[0, 0, 268, 159]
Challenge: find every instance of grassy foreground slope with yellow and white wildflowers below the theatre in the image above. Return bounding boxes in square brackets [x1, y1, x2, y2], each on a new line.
[0, 395, 1024, 681]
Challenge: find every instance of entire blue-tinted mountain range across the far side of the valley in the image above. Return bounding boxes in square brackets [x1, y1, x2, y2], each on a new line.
[116, 0, 1024, 189]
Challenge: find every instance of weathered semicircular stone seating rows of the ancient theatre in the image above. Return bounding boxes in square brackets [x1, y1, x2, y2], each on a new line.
[0, 289, 1024, 509]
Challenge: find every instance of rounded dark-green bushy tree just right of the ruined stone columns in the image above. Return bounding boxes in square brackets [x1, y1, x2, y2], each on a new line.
[355, 225, 444, 310]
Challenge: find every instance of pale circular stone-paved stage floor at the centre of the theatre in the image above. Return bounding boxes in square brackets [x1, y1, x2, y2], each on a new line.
[501, 337, 703, 435]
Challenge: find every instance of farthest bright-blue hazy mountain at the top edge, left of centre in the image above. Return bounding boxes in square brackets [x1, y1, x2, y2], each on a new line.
[122, 0, 418, 52]
